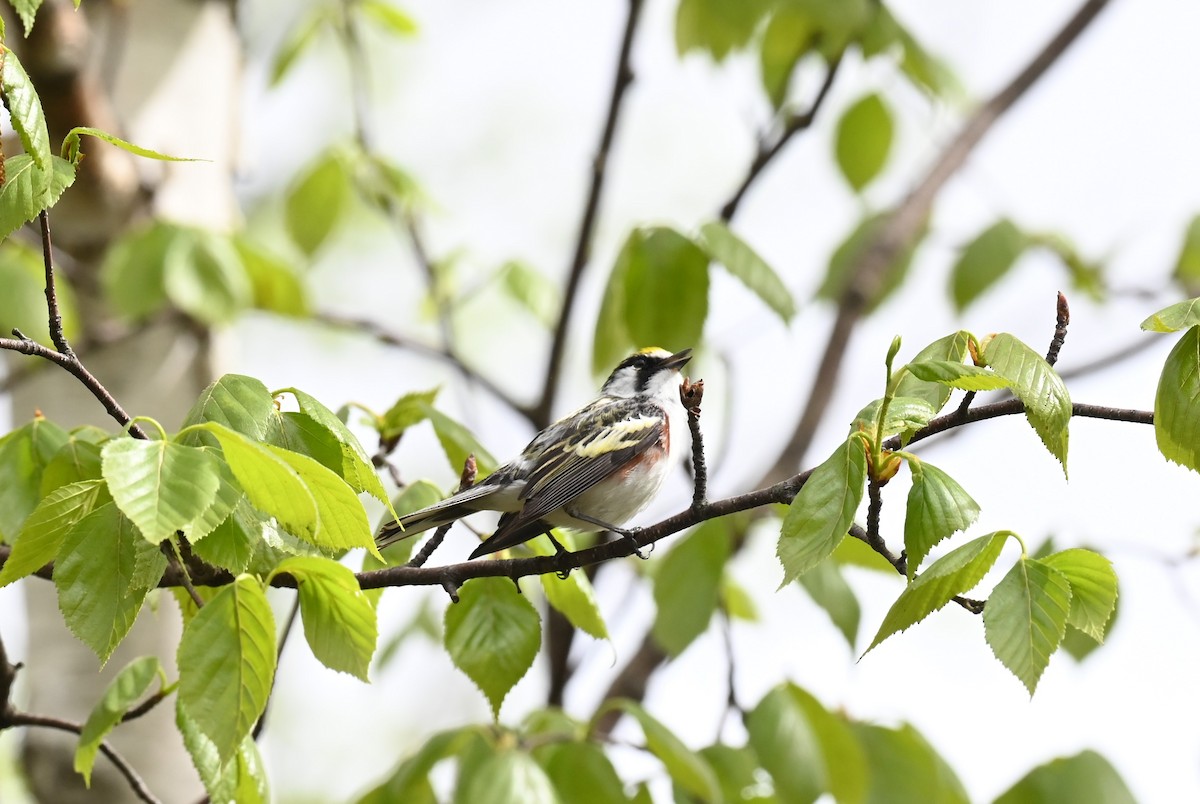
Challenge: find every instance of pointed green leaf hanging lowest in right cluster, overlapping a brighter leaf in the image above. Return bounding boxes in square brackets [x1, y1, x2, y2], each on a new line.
[983, 556, 1070, 696]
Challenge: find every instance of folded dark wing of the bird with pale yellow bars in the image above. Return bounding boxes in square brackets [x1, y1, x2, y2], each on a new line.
[505, 400, 667, 529]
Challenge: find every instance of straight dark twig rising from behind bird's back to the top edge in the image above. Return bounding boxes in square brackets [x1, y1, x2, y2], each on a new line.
[533, 0, 642, 427]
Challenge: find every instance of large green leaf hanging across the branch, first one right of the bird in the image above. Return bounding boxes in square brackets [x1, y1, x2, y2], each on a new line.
[775, 436, 866, 587]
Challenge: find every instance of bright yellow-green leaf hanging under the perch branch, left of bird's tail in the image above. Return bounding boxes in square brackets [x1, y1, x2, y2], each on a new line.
[271, 557, 379, 682]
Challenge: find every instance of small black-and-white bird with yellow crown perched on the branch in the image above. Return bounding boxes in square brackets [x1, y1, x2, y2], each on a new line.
[376, 347, 691, 558]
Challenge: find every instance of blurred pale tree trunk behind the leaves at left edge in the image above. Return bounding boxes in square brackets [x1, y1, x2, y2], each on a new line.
[5, 0, 240, 804]
